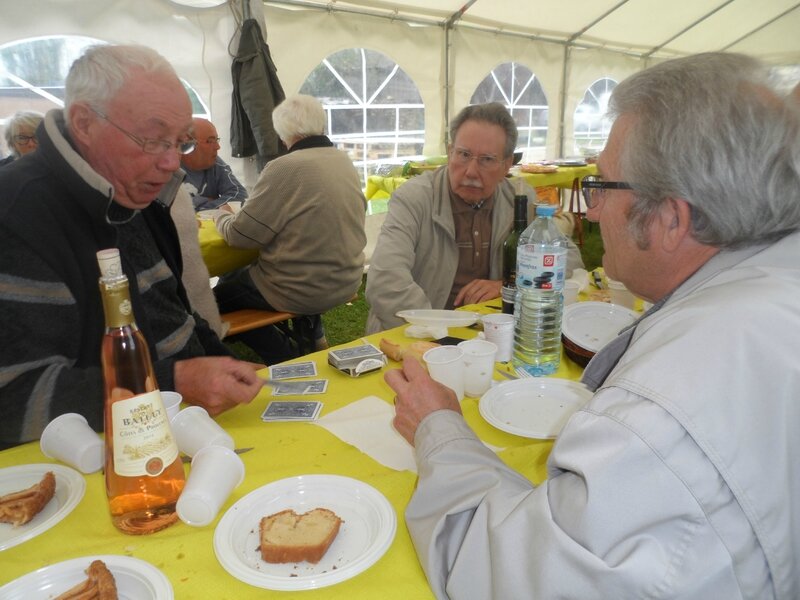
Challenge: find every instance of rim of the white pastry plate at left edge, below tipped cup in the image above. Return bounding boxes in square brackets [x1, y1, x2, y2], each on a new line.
[0, 463, 86, 552]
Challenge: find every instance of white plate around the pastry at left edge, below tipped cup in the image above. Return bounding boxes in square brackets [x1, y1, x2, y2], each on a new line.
[0, 463, 86, 550]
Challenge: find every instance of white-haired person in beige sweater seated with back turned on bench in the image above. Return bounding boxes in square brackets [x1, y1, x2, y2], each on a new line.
[214, 94, 367, 364]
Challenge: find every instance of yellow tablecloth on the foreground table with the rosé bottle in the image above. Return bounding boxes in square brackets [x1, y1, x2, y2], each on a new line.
[0, 301, 581, 600]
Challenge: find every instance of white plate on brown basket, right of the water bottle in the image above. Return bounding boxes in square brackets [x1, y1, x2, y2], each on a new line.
[561, 302, 639, 353]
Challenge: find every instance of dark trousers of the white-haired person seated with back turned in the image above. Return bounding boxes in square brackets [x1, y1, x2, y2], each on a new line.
[214, 269, 325, 365]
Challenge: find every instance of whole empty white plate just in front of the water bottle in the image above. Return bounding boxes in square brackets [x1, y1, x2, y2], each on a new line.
[478, 377, 592, 439]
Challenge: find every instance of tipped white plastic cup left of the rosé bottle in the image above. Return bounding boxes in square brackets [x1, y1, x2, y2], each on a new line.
[39, 413, 105, 473]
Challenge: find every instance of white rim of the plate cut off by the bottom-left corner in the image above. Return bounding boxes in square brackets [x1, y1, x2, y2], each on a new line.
[0, 554, 175, 600]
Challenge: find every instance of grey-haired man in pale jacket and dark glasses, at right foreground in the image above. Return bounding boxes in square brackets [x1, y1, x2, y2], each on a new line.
[386, 53, 800, 600]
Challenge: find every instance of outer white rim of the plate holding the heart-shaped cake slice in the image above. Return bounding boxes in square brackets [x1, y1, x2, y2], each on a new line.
[214, 475, 397, 591]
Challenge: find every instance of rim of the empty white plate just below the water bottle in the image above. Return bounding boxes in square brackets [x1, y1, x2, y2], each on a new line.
[478, 377, 592, 440]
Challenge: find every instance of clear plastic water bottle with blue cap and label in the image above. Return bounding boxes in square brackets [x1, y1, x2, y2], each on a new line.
[511, 205, 567, 377]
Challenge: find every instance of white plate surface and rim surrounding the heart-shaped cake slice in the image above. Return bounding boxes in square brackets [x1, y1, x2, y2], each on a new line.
[214, 475, 397, 591]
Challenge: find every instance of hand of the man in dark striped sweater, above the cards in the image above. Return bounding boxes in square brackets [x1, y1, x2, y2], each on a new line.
[175, 356, 263, 416]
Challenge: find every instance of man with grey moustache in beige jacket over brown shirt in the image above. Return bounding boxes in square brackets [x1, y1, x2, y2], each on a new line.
[366, 102, 583, 333]
